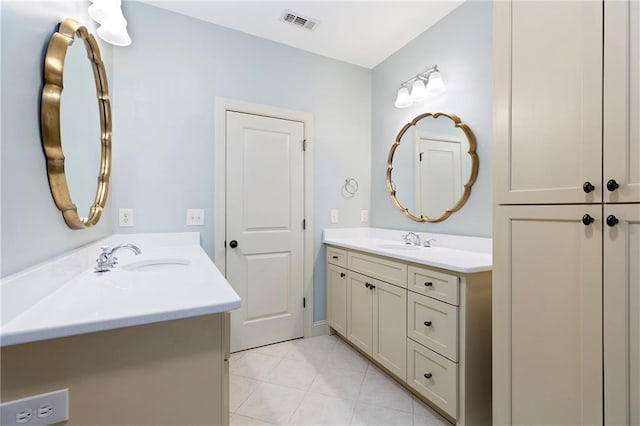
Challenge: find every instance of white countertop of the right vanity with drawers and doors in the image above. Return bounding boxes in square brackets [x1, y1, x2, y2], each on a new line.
[323, 228, 493, 274]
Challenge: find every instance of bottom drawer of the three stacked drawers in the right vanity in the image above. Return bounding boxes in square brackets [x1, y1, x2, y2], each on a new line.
[407, 339, 458, 419]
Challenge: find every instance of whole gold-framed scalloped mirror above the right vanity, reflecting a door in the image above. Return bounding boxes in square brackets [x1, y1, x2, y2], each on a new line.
[387, 112, 478, 222]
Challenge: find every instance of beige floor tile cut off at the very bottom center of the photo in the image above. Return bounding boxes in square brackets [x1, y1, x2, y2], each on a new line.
[289, 393, 355, 426]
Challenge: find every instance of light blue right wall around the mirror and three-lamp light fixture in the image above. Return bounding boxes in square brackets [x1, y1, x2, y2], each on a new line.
[371, 1, 492, 237]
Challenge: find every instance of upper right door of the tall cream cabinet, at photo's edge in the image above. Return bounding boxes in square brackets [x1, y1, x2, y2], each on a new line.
[603, 0, 640, 203]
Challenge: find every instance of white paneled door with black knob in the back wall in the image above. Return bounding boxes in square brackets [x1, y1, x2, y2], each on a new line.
[226, 111, 304, 351]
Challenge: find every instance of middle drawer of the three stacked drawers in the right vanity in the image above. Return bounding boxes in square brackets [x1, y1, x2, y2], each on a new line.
[407, 292, 458, 361]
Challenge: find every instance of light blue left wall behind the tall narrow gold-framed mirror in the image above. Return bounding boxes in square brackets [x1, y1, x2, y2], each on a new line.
[0, 1, 112, 276]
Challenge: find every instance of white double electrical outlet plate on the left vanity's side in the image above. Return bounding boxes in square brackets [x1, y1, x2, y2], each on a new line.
[0, 389, 69, 426]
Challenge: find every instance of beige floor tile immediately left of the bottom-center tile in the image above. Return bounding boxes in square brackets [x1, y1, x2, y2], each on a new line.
[236, 383, 304, 425]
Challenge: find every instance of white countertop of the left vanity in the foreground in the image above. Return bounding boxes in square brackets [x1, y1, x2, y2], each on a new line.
[0, 233, 240, 346]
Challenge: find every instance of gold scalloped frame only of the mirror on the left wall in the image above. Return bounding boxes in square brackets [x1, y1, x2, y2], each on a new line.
[40, 19, 111, 229]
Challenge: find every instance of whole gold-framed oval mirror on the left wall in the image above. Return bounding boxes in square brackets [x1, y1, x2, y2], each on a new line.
[40, 19, 111, 229]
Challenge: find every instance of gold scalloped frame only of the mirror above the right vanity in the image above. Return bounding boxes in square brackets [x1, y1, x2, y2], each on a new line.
[387, 112, 478, 223]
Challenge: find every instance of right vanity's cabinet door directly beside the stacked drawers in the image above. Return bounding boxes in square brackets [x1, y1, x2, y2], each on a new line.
[373, 280, 407, 380]
